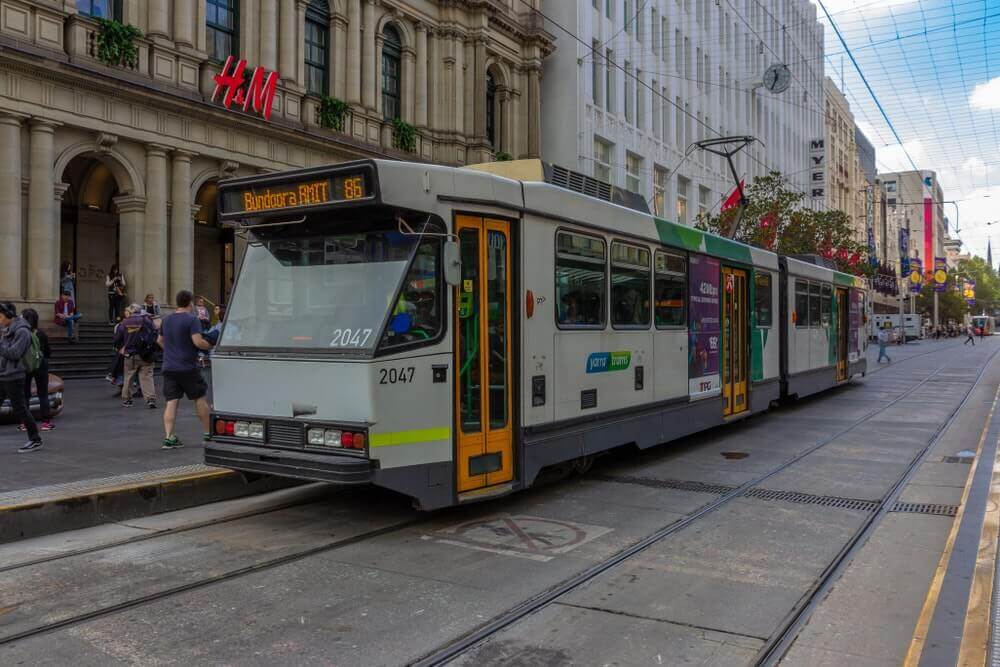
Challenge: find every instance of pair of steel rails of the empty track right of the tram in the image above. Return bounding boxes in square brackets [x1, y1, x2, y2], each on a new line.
[410, 346, 1000, 667]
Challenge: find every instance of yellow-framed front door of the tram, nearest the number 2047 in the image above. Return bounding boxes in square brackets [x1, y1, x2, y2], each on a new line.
[454, 215, 514, 493]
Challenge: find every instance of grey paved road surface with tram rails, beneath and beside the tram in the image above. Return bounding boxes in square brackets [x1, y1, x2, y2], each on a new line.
[0, 337, 1000, 665]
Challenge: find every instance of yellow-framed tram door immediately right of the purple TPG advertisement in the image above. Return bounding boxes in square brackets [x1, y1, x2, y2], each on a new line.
[719, 266, 750, 417]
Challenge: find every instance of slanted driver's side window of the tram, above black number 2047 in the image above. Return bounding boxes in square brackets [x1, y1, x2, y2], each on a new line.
[380, 239, 441, 349]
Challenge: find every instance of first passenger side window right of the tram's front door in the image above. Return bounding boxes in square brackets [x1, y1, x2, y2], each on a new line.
[556, 232, 608, 329]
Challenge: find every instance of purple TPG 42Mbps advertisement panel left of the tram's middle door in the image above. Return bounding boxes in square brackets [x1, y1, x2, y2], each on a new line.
[688, 253, 722, 400]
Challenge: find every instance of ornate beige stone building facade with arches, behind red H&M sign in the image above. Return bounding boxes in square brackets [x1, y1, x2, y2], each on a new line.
[0, 0, 554, 319]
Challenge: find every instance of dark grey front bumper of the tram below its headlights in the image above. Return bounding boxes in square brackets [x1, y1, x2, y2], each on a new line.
[205, 440, 375, 484]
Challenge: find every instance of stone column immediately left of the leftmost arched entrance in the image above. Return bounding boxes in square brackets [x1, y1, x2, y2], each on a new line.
[26, 118, 59, 302]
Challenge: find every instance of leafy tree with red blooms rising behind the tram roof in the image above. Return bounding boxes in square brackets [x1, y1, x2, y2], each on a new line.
[695, 171, 870, 275]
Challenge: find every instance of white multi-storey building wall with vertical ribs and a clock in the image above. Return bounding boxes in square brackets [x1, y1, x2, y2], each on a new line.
[541, 0, 824, 224]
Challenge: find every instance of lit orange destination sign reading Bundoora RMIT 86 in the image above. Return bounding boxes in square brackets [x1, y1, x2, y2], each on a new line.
[222, 173, 370, 214]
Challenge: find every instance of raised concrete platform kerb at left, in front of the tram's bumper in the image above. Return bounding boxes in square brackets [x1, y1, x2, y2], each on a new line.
[0, 465, 299, 544]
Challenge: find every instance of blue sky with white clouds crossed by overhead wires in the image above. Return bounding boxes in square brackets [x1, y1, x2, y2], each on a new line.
[804, 0, 1000, 263]
